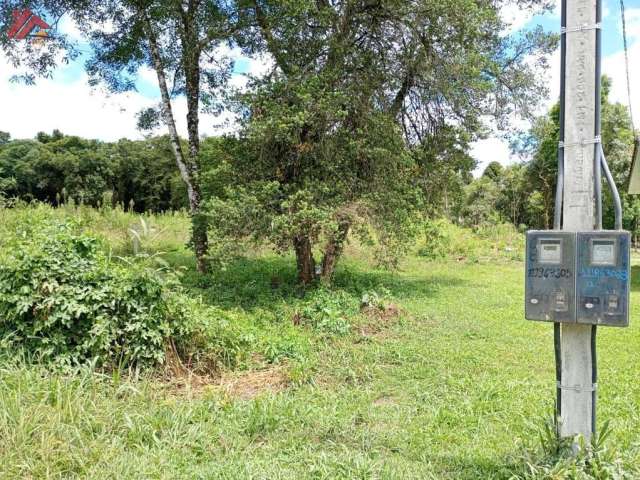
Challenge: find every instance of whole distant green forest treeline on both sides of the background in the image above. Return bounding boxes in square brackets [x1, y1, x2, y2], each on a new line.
[0, 77, 640, 238]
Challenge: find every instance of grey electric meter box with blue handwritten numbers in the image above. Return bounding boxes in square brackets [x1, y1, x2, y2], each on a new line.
[576, 231, 631, 327]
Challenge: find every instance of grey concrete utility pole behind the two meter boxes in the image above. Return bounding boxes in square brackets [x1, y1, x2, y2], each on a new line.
[560, 0, 601, 439]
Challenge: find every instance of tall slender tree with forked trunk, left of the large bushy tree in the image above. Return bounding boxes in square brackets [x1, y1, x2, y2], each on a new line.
[0, 0, 234, 272]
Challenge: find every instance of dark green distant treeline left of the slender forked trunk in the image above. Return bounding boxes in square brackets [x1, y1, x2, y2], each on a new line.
[0, 131, 188, 212]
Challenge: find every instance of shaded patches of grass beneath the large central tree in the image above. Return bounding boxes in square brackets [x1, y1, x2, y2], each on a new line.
[165, 252, 464, 310]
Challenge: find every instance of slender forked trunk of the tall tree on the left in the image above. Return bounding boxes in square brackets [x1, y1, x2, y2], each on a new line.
[142, 12, 208, 273]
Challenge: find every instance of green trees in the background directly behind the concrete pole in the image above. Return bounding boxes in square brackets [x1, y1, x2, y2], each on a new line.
[465, 77, 640, 232]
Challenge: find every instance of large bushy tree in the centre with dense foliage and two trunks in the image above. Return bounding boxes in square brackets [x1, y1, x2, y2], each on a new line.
[210, 0, 555, 283]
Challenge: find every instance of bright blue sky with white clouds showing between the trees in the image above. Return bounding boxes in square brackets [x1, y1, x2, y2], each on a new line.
[0, 0, 640, 173]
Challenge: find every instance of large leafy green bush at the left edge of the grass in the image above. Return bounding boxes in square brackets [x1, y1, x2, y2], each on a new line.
[0, 222, 171, 366]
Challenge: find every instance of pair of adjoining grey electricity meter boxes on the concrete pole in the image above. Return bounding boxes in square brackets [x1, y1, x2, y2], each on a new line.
[525, 230, 631, 327]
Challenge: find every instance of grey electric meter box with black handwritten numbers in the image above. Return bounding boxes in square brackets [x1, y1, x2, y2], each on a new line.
[525, 230, 576, 323]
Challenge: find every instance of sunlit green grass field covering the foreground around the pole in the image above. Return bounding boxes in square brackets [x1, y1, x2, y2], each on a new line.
[0, 205, 640, 479]
